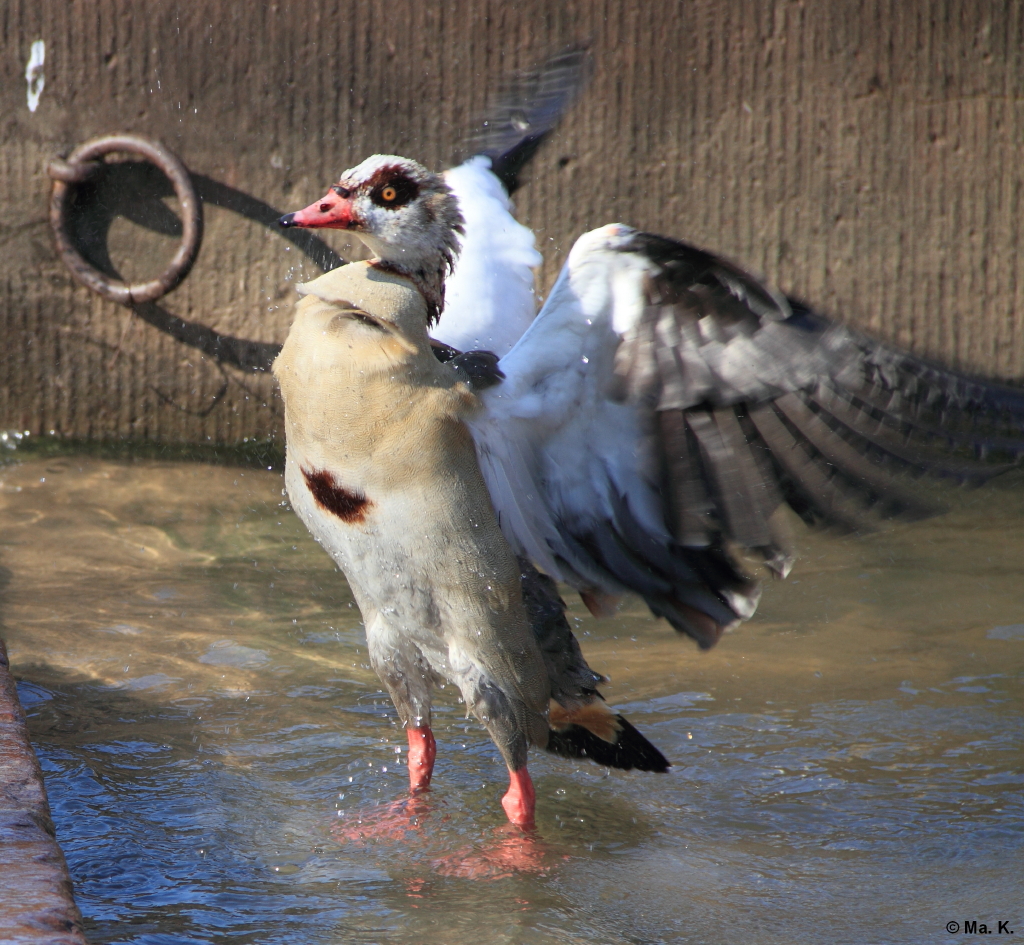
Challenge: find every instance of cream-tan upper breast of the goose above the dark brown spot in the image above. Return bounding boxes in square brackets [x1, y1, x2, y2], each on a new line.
[273, 263, 478, 491]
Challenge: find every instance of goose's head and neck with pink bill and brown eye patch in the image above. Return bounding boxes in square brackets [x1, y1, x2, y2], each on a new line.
[279, 155, 463, 321]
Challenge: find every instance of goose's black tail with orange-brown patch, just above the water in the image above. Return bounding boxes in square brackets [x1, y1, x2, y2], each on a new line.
[547, 699, 671, 772]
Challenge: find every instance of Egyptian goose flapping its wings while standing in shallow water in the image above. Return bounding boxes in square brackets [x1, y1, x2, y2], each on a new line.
[276, 149, 1024, 825]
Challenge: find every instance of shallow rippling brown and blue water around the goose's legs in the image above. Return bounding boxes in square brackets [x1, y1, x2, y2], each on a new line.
[0, 456, 1024, 945]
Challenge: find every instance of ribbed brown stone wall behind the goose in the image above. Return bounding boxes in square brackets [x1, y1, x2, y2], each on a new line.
[0, 0, 1024, 441]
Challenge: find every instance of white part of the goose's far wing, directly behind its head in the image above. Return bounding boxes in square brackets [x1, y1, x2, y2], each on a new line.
[431, 157, 542, 356]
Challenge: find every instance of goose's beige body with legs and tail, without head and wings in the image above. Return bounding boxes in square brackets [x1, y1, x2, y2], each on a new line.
[273, 249, 668, 827]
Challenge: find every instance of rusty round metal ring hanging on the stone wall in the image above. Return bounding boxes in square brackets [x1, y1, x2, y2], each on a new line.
[46, 134, 203, 305]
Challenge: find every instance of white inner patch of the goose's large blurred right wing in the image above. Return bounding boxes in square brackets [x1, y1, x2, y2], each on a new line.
[469, 225, 671, 593]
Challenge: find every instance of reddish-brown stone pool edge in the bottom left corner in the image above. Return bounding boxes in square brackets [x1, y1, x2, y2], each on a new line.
[0, 639, 86, 945]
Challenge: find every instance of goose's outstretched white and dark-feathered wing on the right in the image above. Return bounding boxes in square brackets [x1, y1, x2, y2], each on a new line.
[472, 225, 1024, 646]
